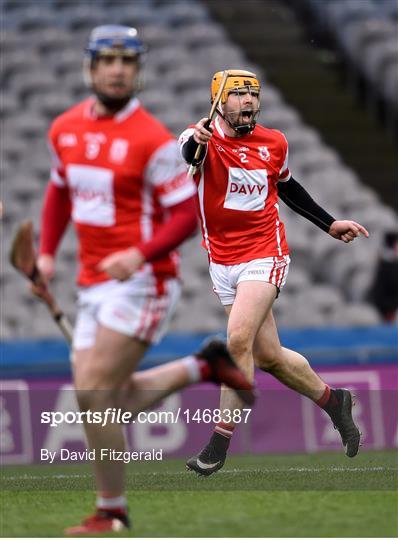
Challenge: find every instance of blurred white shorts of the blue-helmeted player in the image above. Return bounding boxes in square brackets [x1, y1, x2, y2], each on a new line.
[73, 272, 181, 350]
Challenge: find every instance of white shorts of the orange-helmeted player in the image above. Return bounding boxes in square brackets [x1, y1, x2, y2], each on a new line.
[209, 255, 290, 306]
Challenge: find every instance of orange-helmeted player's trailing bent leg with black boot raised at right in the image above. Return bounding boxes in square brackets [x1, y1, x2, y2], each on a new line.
[254, 312, 360, 457]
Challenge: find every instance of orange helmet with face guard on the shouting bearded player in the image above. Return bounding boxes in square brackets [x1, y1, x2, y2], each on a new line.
[211, 69, 261, 135]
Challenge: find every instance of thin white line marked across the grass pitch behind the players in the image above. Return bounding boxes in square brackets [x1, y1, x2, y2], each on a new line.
[2, 467, 398, 482]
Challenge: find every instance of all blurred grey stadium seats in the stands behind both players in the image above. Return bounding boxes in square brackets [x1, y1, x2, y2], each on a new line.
[0, 0, 397, 338]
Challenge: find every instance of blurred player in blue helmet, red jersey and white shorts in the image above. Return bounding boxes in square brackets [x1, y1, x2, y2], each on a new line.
[33, 34, 253, 535]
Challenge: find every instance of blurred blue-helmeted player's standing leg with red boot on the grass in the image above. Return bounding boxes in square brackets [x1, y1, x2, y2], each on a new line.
[65, 326, 148, 535]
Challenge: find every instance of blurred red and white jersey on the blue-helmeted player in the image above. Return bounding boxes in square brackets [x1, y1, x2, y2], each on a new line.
[49, 98, 196, 286]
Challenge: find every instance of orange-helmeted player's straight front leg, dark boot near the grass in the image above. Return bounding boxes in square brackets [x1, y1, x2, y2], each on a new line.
[187, 281, 276, 476]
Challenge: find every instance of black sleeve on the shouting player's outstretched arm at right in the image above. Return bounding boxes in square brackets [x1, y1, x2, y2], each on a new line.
[278, 178, 336, 232]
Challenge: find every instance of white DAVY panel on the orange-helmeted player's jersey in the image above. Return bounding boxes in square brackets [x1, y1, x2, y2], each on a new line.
[224, 167, 268, 211]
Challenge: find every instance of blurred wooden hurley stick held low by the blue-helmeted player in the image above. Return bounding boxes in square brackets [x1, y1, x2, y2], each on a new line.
[10, 221, 73, 344]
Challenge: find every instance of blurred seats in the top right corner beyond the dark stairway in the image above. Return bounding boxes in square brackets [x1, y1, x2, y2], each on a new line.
[302, 0, 398, 128]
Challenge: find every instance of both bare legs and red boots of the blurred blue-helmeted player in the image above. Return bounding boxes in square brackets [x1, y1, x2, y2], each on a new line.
[66, 326, 254, 535]
